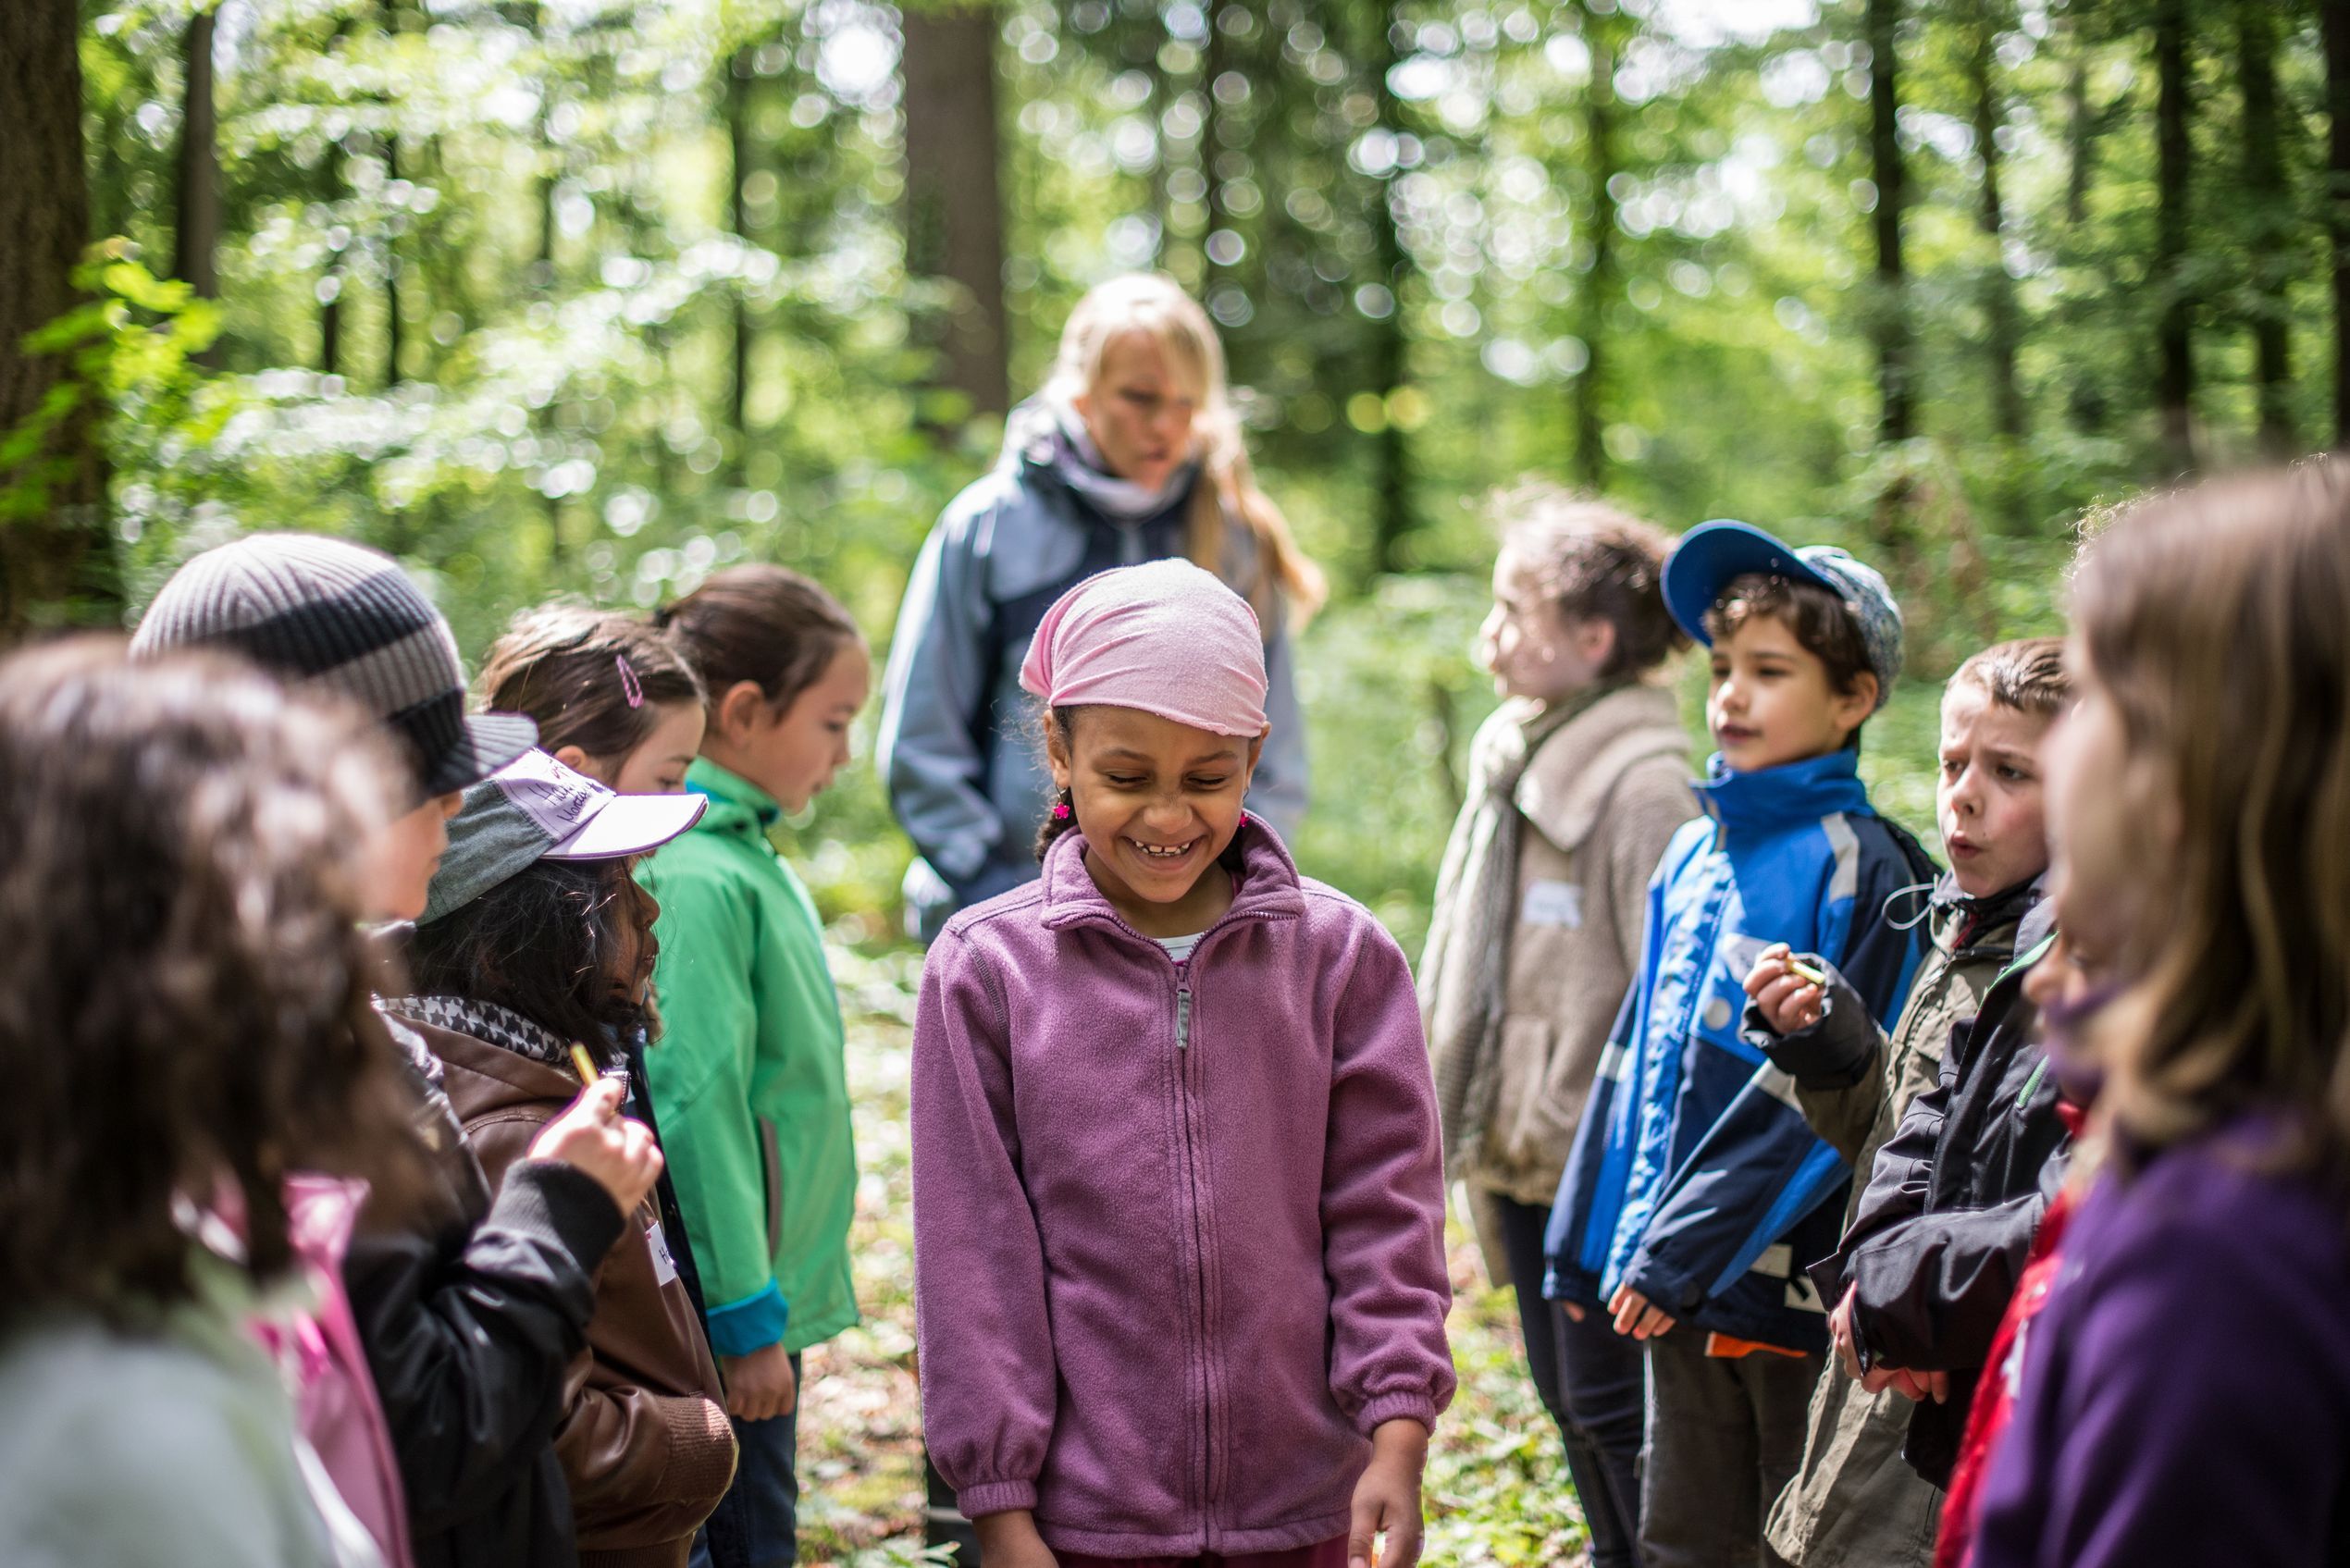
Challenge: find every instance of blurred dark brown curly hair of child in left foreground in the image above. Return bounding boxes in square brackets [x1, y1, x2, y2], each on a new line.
[0, 639, 418, 1316]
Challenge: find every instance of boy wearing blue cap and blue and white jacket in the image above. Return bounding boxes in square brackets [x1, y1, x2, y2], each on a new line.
[1544, 522, 1934, 1568]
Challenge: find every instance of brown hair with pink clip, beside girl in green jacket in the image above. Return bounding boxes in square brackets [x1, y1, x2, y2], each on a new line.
[482, 604, 702, 764]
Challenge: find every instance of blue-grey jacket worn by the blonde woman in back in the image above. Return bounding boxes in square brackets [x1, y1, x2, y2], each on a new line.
[876, 400, 1306, 940]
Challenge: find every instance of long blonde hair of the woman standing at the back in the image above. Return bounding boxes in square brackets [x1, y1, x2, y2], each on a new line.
[1045, 273, 1328, 623]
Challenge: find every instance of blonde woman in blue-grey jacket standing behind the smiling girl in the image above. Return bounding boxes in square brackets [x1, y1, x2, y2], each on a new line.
[879, 273, 1323, 938]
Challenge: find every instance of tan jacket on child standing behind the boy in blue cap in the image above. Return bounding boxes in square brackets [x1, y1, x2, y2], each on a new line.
[1471, 686, 1697, 1206]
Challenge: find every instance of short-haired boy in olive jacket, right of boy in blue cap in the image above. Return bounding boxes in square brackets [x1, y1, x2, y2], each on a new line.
[1746, 637, 2071, 1568]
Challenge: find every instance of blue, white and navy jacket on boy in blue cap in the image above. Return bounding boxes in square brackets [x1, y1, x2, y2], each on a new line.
[1544, 752, 1934, 1350]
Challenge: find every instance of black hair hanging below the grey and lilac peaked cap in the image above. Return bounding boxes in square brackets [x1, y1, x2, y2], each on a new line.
[409, 860, 658, 1065]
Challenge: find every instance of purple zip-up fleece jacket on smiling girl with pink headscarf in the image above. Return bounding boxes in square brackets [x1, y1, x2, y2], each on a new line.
[914, 818, 1453, 1556]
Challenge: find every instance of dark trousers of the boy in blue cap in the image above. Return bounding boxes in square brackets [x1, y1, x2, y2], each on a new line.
[1640, 1324, 1826, 1568]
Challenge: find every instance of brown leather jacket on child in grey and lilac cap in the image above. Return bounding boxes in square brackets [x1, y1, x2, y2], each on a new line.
[414, 1025, 736, 1568]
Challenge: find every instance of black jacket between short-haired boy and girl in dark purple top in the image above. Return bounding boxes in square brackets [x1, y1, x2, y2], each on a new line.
[1814, 905, 2072, 1486]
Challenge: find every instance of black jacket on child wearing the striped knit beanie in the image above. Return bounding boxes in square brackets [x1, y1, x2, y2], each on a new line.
[343, 1025, 621, 1568]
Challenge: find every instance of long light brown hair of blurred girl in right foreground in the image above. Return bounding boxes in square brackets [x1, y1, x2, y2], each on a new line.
[2072, 459, 2350, 1171]
